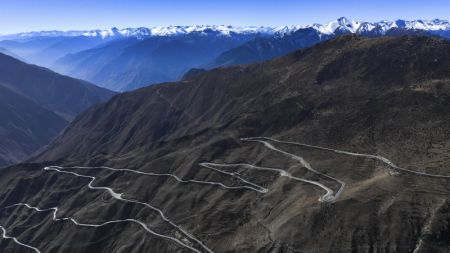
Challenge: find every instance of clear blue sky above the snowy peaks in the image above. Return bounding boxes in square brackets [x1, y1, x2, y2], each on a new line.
[0, 0, 450, 34]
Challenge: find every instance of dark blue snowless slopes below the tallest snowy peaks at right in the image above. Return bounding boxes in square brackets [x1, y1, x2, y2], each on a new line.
[211, 26, 448, 67]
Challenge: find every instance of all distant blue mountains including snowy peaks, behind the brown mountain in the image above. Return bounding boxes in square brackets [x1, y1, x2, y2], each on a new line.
[0, 17, 450, 91]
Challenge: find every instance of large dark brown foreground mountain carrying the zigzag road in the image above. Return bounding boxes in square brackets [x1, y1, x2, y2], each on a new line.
[0, 36, 450, 253]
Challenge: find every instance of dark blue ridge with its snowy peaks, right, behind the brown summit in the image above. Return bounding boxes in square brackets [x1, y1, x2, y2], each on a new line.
[209, 17, 450, 67]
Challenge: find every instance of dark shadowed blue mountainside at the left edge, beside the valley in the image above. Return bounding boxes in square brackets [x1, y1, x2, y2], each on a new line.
[0, 54, 114, 167]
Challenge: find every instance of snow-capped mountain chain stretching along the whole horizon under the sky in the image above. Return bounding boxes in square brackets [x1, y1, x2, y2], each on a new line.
[0, 17, 450, 40]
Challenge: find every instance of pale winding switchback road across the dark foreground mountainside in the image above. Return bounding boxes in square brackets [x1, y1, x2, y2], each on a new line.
[5, 137, 444, 253]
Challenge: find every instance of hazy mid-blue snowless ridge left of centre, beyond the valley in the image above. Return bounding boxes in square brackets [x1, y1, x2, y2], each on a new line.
[53, 32, 268, 91]
